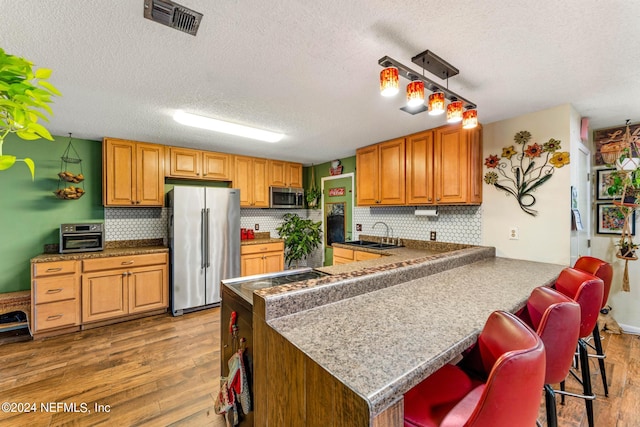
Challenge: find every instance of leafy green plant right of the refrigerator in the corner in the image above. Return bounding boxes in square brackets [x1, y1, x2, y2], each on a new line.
[276, 213, 322, 268]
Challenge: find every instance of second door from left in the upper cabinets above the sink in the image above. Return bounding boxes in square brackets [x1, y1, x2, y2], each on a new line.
[378, 138, 405, 205]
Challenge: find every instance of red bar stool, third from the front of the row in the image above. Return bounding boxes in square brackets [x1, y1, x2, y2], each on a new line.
[555, 267, 604, 427]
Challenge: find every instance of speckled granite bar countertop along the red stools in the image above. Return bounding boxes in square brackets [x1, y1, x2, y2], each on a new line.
[268, 258, 564, 415]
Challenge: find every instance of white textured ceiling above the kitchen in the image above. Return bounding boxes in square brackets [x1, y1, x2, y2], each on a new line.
[5, 0, 640, 164]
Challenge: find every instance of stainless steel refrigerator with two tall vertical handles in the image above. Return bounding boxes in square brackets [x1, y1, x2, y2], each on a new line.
[167, 185, 240, 316]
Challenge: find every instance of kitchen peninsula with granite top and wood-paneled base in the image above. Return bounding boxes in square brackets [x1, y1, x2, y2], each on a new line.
[253, 246, 564, 426]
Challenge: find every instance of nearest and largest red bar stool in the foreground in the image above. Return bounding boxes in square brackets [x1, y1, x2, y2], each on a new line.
[404, 311, 545, 427]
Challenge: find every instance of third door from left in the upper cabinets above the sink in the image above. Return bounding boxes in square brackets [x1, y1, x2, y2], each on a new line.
[406, 130, 435, 205]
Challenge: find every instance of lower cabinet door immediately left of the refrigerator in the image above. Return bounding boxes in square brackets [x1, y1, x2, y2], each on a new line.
[128, 265, 169, 314]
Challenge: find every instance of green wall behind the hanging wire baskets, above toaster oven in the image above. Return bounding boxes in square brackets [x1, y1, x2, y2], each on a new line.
[0, 135, 104, 293]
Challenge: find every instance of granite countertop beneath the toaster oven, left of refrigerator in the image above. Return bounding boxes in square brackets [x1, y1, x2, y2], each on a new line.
[31, 239, 169, 262]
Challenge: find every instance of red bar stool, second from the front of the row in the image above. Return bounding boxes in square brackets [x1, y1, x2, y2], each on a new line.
[518, 287, 580, 427]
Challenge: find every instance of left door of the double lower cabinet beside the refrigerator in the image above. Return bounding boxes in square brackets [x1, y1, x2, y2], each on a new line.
[82, 270, 129, 322]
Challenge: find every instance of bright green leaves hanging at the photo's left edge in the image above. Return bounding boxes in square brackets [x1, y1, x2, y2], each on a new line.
[0, 48, 61, 180]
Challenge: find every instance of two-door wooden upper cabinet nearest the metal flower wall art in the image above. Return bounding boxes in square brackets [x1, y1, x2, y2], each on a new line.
[406, 125, 482, 205]
